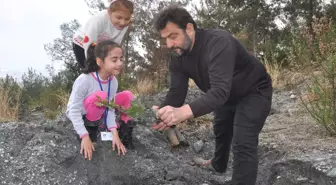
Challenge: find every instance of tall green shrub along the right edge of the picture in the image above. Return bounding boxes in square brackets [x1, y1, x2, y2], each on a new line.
[303, 19, 336, 135]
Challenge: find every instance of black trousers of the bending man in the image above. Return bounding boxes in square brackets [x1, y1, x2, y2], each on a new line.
[212, 82, 272, 185]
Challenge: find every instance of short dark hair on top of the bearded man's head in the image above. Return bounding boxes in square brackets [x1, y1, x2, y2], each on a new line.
[154, 5, 197, 31]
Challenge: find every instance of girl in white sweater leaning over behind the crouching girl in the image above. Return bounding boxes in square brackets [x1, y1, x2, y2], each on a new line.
[72, 0, 133, 68]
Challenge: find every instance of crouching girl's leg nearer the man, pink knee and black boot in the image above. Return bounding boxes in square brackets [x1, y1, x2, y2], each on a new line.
[114, 90, 135, 150]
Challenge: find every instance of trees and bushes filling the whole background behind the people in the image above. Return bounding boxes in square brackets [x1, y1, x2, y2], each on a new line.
[0, 0, 336, 124]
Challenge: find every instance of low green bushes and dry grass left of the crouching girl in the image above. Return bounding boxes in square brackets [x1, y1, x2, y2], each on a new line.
[0, 68, 69, 119]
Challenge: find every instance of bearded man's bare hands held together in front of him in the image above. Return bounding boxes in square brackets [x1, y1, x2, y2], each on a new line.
[152, 105, 193, 131]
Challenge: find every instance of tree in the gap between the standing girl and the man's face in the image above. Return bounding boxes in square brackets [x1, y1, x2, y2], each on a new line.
[134, 0, 190, 89]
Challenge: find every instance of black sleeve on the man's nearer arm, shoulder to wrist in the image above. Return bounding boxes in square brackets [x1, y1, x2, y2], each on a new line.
[189, 37, 237, 117]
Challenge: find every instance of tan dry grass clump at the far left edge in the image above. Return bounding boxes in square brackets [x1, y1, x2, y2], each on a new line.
[0, 88, 22, 121]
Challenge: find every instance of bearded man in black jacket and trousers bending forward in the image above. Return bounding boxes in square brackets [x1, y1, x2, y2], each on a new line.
[152, 6, 272, 185]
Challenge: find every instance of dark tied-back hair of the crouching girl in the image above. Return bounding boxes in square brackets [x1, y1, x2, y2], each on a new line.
[83, 40, 121, 74]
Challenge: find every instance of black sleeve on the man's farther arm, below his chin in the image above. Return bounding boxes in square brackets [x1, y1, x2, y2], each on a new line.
[160, 58, 189, 108]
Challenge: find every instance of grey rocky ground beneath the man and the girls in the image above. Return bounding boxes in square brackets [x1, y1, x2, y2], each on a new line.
[0, 89, 336, 185]
